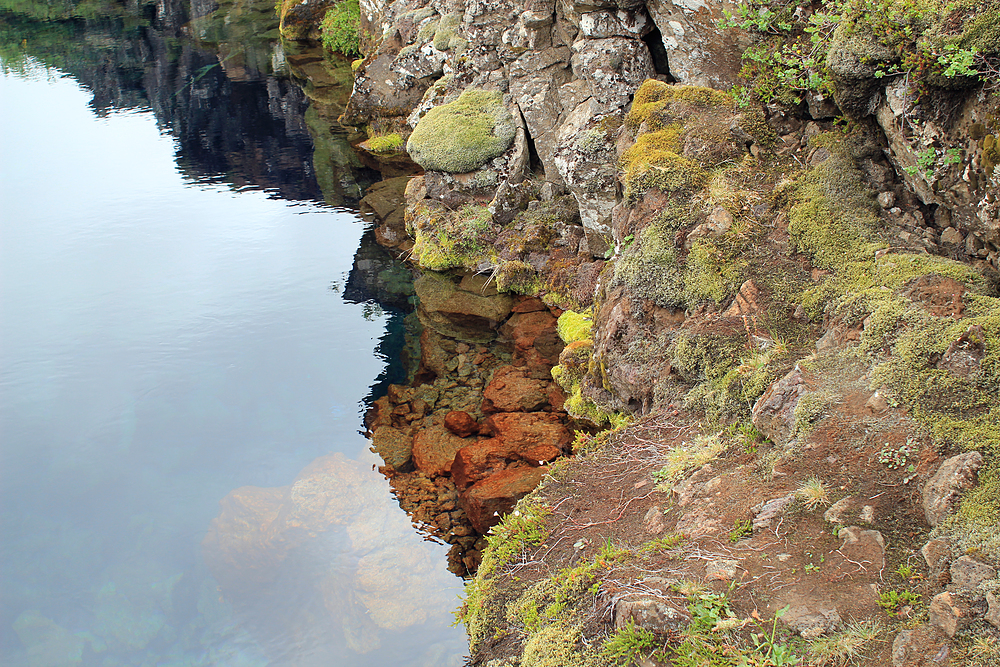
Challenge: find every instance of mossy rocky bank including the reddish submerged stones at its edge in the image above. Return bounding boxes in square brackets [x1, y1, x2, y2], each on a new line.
[286, 0, 1000, 666]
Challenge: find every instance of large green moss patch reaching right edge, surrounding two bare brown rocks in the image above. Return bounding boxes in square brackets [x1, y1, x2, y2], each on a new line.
[789, 130, 1000, 450]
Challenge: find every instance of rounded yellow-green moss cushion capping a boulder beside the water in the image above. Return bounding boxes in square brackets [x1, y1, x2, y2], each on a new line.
[406, 88, 515, 173]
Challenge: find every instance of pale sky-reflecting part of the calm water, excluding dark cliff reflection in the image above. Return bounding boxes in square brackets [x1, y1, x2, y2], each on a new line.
[0, 63, 465, 667]
